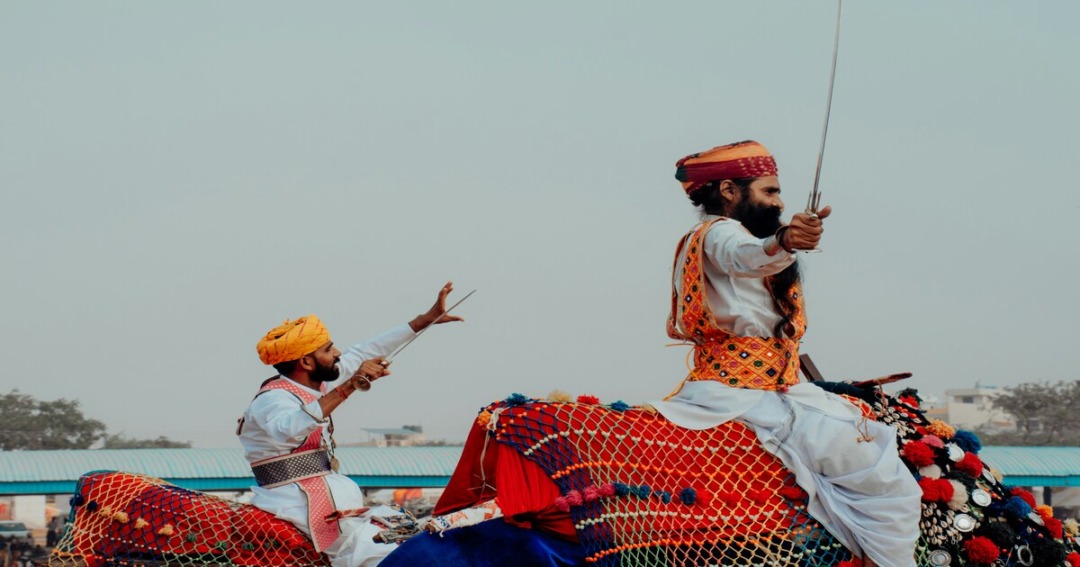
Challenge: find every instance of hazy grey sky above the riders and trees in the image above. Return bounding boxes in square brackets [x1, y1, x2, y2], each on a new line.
[0, 0, 1080, 447]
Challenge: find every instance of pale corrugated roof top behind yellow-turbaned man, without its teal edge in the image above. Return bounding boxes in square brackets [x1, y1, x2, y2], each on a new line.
[0, 447, 461, 483]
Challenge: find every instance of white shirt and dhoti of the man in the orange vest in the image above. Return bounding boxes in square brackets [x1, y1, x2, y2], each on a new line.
[650, 220, 922, 567]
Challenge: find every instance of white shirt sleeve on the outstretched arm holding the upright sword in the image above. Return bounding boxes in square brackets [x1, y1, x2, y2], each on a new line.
[704, 219, 795, 278]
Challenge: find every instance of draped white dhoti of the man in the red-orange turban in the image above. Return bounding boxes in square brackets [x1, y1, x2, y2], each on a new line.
[650, 380, 922, 567]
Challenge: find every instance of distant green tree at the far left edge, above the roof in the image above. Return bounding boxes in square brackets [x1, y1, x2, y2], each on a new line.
[0, 390, 105, 450]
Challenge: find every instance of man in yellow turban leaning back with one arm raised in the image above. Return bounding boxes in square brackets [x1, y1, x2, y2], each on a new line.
[237, 283, 462, 567]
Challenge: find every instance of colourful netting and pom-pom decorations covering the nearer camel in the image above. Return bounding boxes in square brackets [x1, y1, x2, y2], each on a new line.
[477, 384, 1080, 567]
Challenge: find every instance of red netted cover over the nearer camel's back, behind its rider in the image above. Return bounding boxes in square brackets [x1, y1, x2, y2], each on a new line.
[487, 401, 850, 566]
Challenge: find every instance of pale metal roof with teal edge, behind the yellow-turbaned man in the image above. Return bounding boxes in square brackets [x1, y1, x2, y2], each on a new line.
[0, 447, 461, 495]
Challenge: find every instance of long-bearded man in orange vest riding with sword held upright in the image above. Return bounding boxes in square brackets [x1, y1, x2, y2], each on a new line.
[651, 141, 921, 567]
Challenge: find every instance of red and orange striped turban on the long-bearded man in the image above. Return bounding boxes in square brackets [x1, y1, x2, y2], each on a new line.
[675, 140, 777, 194]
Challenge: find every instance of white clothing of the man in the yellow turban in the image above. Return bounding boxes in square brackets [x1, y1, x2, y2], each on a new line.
[240, 324, 415, 567]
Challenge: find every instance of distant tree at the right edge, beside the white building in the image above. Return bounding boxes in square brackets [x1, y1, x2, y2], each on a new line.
[980, 380, 1080, 446]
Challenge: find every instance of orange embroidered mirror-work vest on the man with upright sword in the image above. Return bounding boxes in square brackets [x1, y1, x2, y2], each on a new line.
[667, 219, 806, 390]
